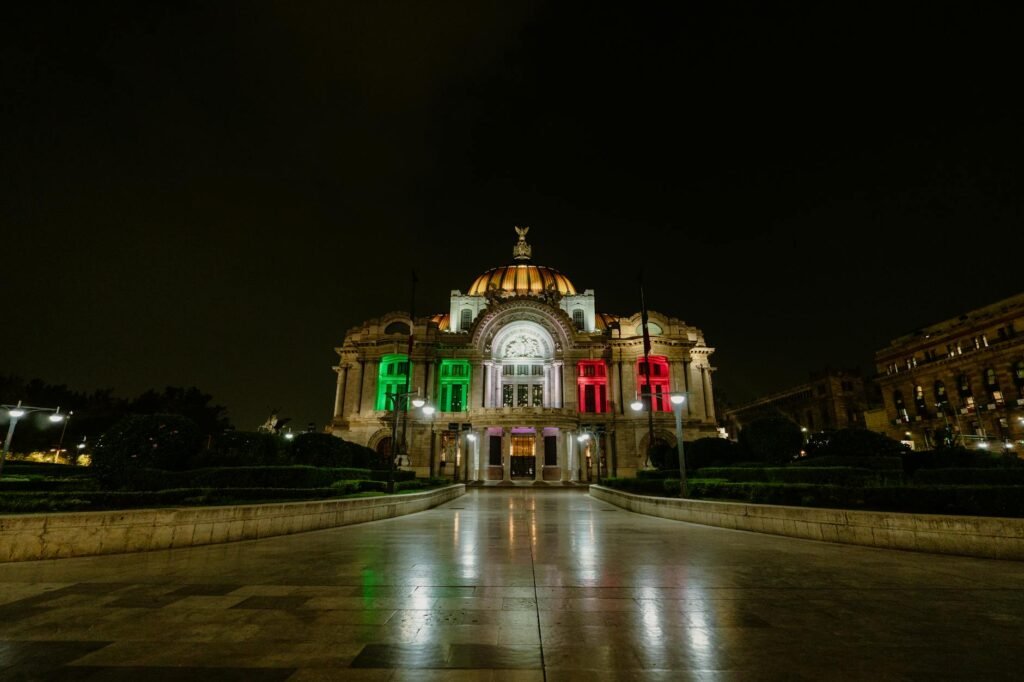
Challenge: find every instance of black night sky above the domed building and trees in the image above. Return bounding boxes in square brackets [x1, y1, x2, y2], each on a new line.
[0, 0, 1024, 428]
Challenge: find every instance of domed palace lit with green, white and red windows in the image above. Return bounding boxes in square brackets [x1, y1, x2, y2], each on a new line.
[330, 228, 716, 481]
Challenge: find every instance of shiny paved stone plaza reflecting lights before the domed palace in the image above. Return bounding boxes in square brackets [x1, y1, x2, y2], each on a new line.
[0, 488, 1024, 682]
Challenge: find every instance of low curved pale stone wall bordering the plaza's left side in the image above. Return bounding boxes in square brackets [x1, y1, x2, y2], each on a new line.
[0, 484, 466, 562]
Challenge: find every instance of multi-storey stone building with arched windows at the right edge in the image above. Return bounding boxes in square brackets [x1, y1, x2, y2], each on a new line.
[874, 294, 1024, 453]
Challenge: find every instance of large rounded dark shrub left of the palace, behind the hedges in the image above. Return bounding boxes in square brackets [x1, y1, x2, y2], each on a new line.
[92, 415, 200, 486]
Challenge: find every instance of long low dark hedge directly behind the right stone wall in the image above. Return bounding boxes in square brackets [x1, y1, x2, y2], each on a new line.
[690, 480, 1024, 516]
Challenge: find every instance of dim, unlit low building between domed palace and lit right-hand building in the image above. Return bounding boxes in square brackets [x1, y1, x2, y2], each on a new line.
[725, 370, 871, 437]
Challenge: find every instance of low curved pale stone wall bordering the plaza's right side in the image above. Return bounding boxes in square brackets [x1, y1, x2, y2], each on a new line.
[590, 485, 1024, 560]
